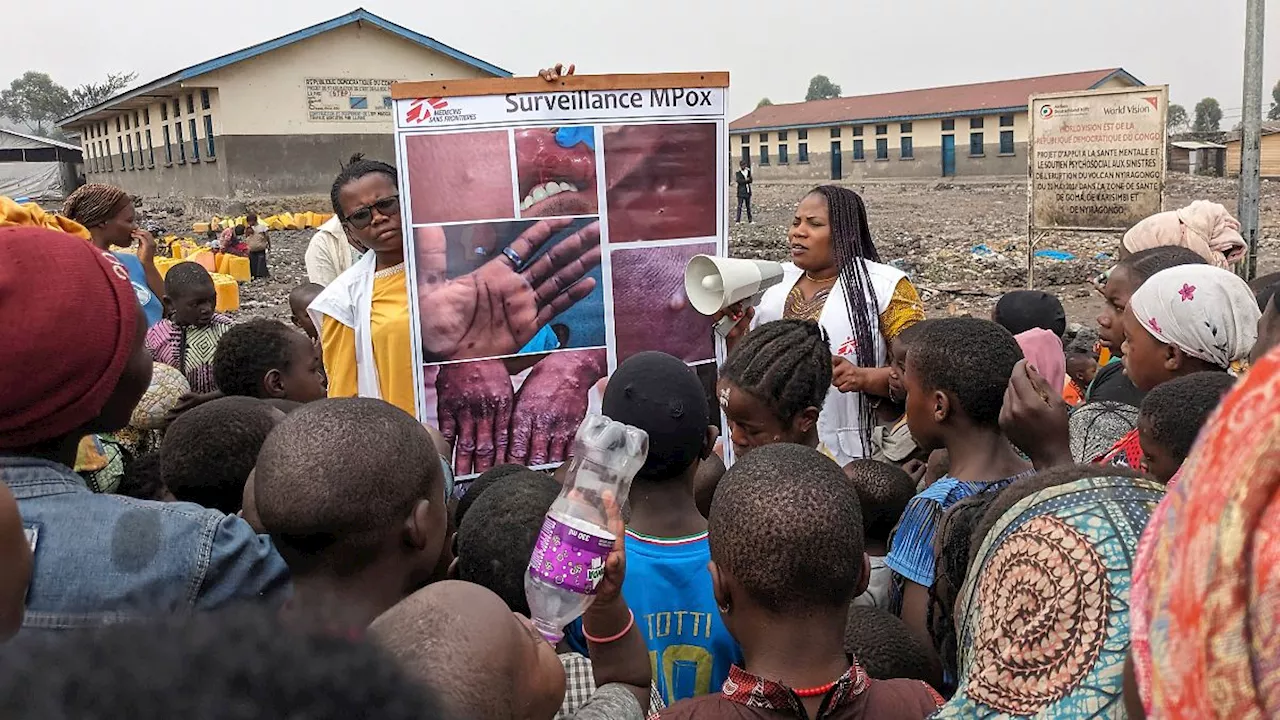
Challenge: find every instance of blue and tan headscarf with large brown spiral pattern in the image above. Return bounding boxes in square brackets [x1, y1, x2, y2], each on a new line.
[937, 478, 1164, 719]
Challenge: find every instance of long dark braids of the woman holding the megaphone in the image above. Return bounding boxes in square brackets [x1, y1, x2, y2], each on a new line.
[813, 184, 881, 447]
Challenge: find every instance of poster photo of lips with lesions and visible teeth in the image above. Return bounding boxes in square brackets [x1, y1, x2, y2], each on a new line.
[516, 126, 600, 218]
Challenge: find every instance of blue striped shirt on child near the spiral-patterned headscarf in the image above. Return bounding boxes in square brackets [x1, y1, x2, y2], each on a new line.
[884, 473, 1029, 588]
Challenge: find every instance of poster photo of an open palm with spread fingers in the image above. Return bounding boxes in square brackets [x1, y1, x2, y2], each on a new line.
[413, 218, 605, 363]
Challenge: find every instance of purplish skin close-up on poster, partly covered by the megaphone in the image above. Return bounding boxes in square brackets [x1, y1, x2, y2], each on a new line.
[609, 242, 716, 363]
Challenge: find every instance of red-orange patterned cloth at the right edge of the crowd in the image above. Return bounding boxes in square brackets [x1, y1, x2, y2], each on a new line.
[1134, 350, 1280, 720]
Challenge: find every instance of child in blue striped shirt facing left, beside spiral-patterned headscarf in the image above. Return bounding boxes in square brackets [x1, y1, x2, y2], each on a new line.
[884, 318, 1032, 639]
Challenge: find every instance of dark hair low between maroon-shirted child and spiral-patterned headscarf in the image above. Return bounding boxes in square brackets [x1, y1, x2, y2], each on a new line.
[845, 605, 942, 689]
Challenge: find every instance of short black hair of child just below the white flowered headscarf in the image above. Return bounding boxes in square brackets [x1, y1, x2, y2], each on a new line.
[1139, 372, 1235, 460]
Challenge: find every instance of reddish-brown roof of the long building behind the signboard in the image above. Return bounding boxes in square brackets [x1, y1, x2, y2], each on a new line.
[730, 68, 1143, 132]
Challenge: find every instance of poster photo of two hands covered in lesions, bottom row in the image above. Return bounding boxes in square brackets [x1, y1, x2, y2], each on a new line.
[424, 348, 608, 477]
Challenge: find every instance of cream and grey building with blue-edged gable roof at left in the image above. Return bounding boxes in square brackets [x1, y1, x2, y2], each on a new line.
[59, 9, 511, 199]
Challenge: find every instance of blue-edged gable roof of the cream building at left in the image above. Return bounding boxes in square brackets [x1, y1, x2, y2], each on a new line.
[58, 8, 511, 127]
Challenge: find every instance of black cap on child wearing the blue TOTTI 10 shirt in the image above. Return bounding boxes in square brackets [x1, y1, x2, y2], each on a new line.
[600, 351, 709, 482]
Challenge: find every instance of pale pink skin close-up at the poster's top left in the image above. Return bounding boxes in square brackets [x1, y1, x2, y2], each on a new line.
[404, 129, 516, 225]
